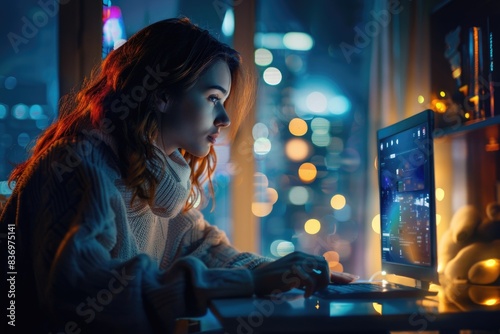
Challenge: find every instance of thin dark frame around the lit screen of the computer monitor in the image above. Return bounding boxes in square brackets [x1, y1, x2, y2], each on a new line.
[377, 109, 439, 283]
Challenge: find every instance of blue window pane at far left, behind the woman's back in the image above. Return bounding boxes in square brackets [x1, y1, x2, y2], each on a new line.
[0, 1, 59, 196]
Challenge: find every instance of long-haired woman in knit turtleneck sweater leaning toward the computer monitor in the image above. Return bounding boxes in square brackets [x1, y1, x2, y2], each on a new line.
[1, 19, 358, 333]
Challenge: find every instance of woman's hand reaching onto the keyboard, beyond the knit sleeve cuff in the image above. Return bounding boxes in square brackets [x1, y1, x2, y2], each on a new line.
[252, 252, 330, 297]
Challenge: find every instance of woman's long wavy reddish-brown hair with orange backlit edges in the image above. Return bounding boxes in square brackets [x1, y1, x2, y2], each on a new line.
[9, 18, 254, 210]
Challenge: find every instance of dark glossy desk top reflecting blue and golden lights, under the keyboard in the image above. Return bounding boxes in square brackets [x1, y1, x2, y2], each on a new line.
[211, 287, 500, 334]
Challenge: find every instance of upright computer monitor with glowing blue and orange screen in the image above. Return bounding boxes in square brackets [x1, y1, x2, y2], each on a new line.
[377, 110, 438, 284]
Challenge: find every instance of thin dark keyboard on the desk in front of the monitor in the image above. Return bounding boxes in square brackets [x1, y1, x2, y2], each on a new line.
[315, 282, 437, 299]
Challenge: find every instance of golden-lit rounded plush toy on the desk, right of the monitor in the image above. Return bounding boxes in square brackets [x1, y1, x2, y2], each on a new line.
[438, 203, 500, 305]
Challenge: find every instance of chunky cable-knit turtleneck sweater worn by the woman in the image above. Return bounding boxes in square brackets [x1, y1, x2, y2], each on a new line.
[0, 130, 267, 333]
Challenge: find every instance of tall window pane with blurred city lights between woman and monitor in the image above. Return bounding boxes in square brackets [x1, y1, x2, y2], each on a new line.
[252, 0, 370, 272]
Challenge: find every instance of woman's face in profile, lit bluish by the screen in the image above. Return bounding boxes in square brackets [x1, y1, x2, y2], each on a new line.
[158, 60, 231, 157]
